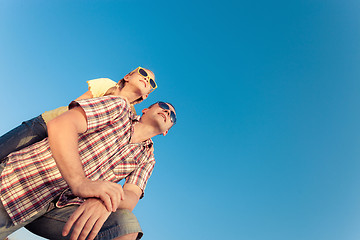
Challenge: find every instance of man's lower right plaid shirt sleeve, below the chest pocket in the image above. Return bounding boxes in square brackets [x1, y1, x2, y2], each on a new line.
[125, 153, 155, 199]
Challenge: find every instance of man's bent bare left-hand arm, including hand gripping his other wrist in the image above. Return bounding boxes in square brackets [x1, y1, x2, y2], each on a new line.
[47, 107, 124, 211]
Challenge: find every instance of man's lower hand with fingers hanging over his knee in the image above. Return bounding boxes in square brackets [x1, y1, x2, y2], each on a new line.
[62, 198, 111, 240]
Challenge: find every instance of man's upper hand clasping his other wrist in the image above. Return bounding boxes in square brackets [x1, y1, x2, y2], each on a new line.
[71, 178, 125, 212]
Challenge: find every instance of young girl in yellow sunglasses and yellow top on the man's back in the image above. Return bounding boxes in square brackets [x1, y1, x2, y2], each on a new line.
[0, 67, 157, 162]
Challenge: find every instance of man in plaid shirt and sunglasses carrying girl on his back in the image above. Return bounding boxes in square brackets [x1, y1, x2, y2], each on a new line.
[0, 96, 176, 239]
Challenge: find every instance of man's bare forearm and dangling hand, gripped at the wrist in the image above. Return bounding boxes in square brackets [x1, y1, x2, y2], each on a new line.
[62, 184, 142, 239]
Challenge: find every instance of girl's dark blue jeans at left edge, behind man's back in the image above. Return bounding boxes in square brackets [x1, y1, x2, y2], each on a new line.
[0, 115, 47, 162]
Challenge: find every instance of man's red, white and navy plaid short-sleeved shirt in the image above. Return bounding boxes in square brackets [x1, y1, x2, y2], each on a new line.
[0, 96, 155, 225]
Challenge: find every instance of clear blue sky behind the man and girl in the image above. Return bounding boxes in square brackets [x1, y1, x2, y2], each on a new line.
[0, 0, 360, 240]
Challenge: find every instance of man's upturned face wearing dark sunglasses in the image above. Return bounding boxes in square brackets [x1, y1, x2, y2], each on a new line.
[141, 102, 176, 136]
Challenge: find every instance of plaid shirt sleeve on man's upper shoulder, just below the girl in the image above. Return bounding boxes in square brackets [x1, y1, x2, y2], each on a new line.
[69, 96, 130, 133]
